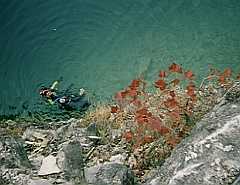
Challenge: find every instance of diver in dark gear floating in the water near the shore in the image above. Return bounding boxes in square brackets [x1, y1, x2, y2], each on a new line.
[39, 81, 90, 111]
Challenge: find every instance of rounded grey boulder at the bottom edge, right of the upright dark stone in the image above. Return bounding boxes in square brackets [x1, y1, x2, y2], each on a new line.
[85, 163, 136, 185]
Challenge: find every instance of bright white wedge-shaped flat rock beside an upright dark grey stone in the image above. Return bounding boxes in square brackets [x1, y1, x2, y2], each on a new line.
[38, 155, 61, 176]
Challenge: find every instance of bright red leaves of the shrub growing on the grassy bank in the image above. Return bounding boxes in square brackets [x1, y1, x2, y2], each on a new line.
[111, 63, 240, 150]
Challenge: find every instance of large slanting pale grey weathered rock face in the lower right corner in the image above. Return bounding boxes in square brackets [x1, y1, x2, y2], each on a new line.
[146, 98, 240, 185]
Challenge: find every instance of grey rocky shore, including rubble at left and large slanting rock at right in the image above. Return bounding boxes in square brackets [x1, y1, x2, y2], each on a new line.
[0, 84, 240, 185]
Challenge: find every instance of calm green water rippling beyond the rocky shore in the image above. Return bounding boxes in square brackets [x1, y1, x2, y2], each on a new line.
[0, 0, 240, 114]
